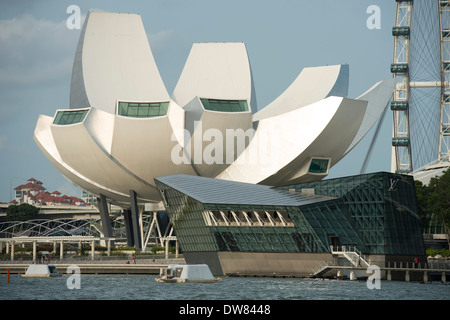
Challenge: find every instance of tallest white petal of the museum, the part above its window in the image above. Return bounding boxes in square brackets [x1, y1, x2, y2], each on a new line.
[70, 11, 169, 114]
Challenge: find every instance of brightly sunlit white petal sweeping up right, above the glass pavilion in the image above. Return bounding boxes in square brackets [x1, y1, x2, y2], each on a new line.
[217, 97, 367, 185]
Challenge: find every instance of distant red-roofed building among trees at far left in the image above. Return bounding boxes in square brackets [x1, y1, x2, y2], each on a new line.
[10, 178, 86, 206]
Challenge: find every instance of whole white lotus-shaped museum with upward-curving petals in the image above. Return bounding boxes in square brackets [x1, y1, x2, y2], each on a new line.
[34, 12, 394, 206]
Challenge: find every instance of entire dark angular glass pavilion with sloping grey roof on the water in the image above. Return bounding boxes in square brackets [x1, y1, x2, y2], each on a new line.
[155, 172, 425, 276]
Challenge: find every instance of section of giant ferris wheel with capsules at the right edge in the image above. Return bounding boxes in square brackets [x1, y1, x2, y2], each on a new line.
[391, 0, 450, 174]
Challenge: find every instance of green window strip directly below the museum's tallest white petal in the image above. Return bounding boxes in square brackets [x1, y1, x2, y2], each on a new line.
[117, 102, 169, 118]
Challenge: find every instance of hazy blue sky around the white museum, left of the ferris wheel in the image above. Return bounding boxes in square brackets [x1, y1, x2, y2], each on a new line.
[0, 0, 396, 202]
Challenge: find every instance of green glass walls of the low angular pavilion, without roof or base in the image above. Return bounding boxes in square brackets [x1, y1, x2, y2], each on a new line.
[155, 173, 425, 255]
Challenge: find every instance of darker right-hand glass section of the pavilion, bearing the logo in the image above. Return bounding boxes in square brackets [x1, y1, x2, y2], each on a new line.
[281, 172, 425, 255]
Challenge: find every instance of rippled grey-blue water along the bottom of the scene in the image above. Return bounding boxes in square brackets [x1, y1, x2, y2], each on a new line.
[0, 274, 450, 300]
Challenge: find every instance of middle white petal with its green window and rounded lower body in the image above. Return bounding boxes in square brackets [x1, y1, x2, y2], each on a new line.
[172, 43, 256, 177]
